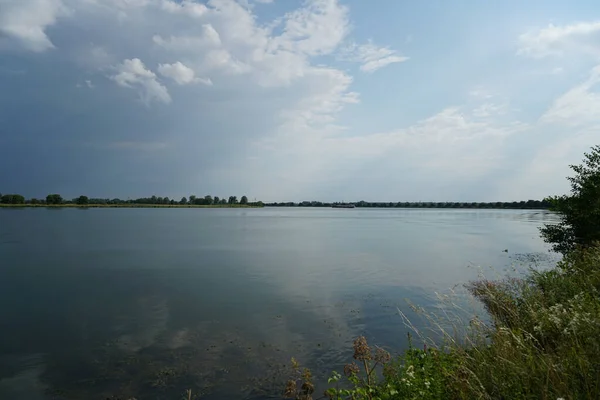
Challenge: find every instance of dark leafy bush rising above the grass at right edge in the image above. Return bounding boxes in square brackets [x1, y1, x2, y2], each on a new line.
[540, 146, 600, 254]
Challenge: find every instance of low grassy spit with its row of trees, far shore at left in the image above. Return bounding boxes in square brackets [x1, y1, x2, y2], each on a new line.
[0, 194, 264, 208]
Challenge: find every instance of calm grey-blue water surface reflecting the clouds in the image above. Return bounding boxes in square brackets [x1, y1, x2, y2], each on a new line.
[0, 208, 553, 399]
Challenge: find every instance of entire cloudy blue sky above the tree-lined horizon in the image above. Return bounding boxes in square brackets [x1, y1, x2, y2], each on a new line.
[0, 0, 600, 201]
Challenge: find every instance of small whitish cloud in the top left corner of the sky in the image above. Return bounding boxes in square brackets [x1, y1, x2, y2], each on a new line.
[0, 0, 68, 52]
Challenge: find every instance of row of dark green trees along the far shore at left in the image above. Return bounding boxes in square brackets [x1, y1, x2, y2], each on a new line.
[0, 193, 263, 207]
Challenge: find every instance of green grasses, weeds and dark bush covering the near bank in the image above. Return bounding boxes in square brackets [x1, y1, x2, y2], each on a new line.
[285, 146, 600, 400]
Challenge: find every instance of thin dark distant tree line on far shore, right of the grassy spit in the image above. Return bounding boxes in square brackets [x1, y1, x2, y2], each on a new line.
[266, 199, 551, 209]
